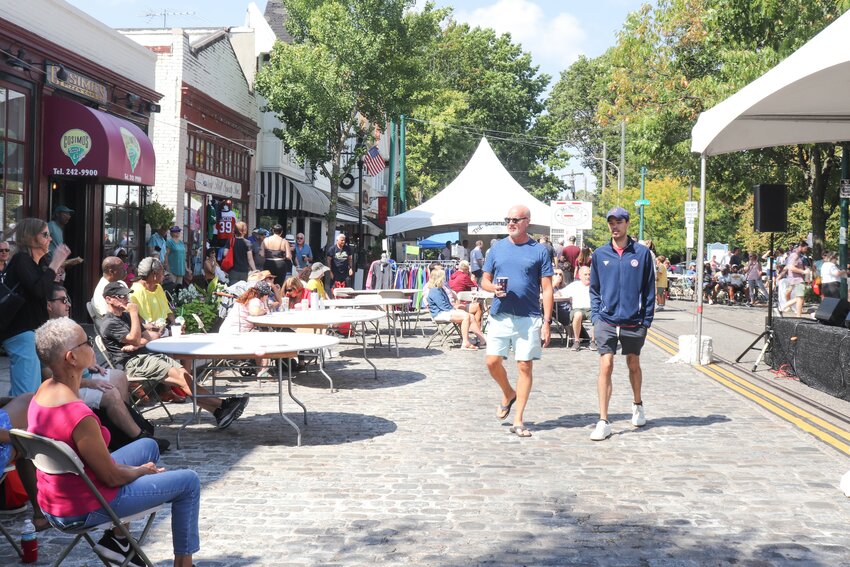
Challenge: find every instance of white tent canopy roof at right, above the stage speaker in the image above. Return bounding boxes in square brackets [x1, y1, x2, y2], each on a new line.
[691, 12, 850, 156]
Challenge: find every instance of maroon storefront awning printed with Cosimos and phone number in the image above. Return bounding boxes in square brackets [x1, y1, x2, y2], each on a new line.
[43, 96, 156, 185]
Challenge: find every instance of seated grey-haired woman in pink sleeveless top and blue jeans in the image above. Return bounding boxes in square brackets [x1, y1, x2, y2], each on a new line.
[32, 317, 201, 567]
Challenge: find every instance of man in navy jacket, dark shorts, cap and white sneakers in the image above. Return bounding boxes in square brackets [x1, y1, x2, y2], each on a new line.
[590, 207, 655, 441]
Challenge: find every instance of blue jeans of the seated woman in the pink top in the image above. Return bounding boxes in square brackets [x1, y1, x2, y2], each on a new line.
[45, 438, 201, 555]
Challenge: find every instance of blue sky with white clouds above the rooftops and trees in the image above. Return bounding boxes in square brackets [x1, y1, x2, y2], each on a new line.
[70, 0, 646, 82]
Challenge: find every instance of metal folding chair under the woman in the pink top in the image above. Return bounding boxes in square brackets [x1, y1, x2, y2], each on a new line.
[9, 429, 162, 567]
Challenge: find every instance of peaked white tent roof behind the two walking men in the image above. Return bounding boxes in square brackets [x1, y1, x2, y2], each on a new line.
[387, 138, 551, 237]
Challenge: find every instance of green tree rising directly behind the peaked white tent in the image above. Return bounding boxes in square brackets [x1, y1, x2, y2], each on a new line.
[400, 22, 557, 209]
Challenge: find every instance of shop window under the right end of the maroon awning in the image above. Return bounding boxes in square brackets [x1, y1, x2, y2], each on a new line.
[103, 185, 144, 265]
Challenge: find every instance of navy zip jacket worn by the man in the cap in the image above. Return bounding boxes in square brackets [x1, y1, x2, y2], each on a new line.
[590, 238, 655, 328]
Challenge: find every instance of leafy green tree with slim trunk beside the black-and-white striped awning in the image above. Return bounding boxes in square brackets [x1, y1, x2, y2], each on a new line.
[256, 0, 445, 247]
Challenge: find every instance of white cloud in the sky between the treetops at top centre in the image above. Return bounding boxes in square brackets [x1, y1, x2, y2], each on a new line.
[455, 0, 587, 80]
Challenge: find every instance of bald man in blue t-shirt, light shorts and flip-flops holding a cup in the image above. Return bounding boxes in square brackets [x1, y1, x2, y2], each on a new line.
[478, 205, 554, 437]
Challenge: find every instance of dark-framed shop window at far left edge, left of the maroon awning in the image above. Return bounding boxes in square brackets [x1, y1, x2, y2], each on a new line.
[0, 85, 28, 239]
